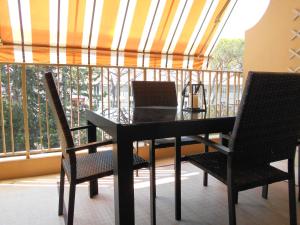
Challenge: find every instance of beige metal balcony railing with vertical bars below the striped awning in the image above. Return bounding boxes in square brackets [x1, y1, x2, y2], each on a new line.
[0, 64, 243, 158]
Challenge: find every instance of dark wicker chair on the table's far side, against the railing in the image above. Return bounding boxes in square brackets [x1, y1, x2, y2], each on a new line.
[132, 81, 199, 190]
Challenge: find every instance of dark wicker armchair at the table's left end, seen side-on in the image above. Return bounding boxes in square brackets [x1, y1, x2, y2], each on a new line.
[45, 73, 148, 225]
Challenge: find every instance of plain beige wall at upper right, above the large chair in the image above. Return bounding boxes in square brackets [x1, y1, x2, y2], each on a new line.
[244, 0, 300, 74]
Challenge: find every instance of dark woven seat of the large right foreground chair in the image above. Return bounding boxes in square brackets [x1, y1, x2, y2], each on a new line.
[185, 152, 289, 190]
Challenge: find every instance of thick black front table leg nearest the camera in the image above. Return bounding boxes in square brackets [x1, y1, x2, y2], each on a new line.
[113, 132, 134, 225]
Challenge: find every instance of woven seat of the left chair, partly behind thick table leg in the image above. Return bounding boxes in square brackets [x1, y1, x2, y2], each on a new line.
[63, 150, 148, 183]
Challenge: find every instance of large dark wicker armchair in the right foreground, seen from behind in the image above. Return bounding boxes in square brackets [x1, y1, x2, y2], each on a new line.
[186, 72, 300, 225]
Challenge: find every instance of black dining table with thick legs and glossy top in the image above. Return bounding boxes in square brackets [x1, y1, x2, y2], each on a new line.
[86, 107, 235, 225]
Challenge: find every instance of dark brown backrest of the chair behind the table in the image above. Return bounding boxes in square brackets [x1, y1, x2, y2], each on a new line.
[132, 81, 177, 107]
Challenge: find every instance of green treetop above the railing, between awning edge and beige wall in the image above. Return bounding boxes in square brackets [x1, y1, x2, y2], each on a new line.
[209, 39, 245, 71]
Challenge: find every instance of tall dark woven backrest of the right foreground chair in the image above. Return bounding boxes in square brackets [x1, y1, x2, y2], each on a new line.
[229, 72, 300, 164]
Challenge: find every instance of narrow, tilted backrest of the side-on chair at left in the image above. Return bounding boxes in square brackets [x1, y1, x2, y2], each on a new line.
[44, 72, 74, 156]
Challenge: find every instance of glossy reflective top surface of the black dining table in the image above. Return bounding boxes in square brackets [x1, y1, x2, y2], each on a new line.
[91, 107, 235, 125]
